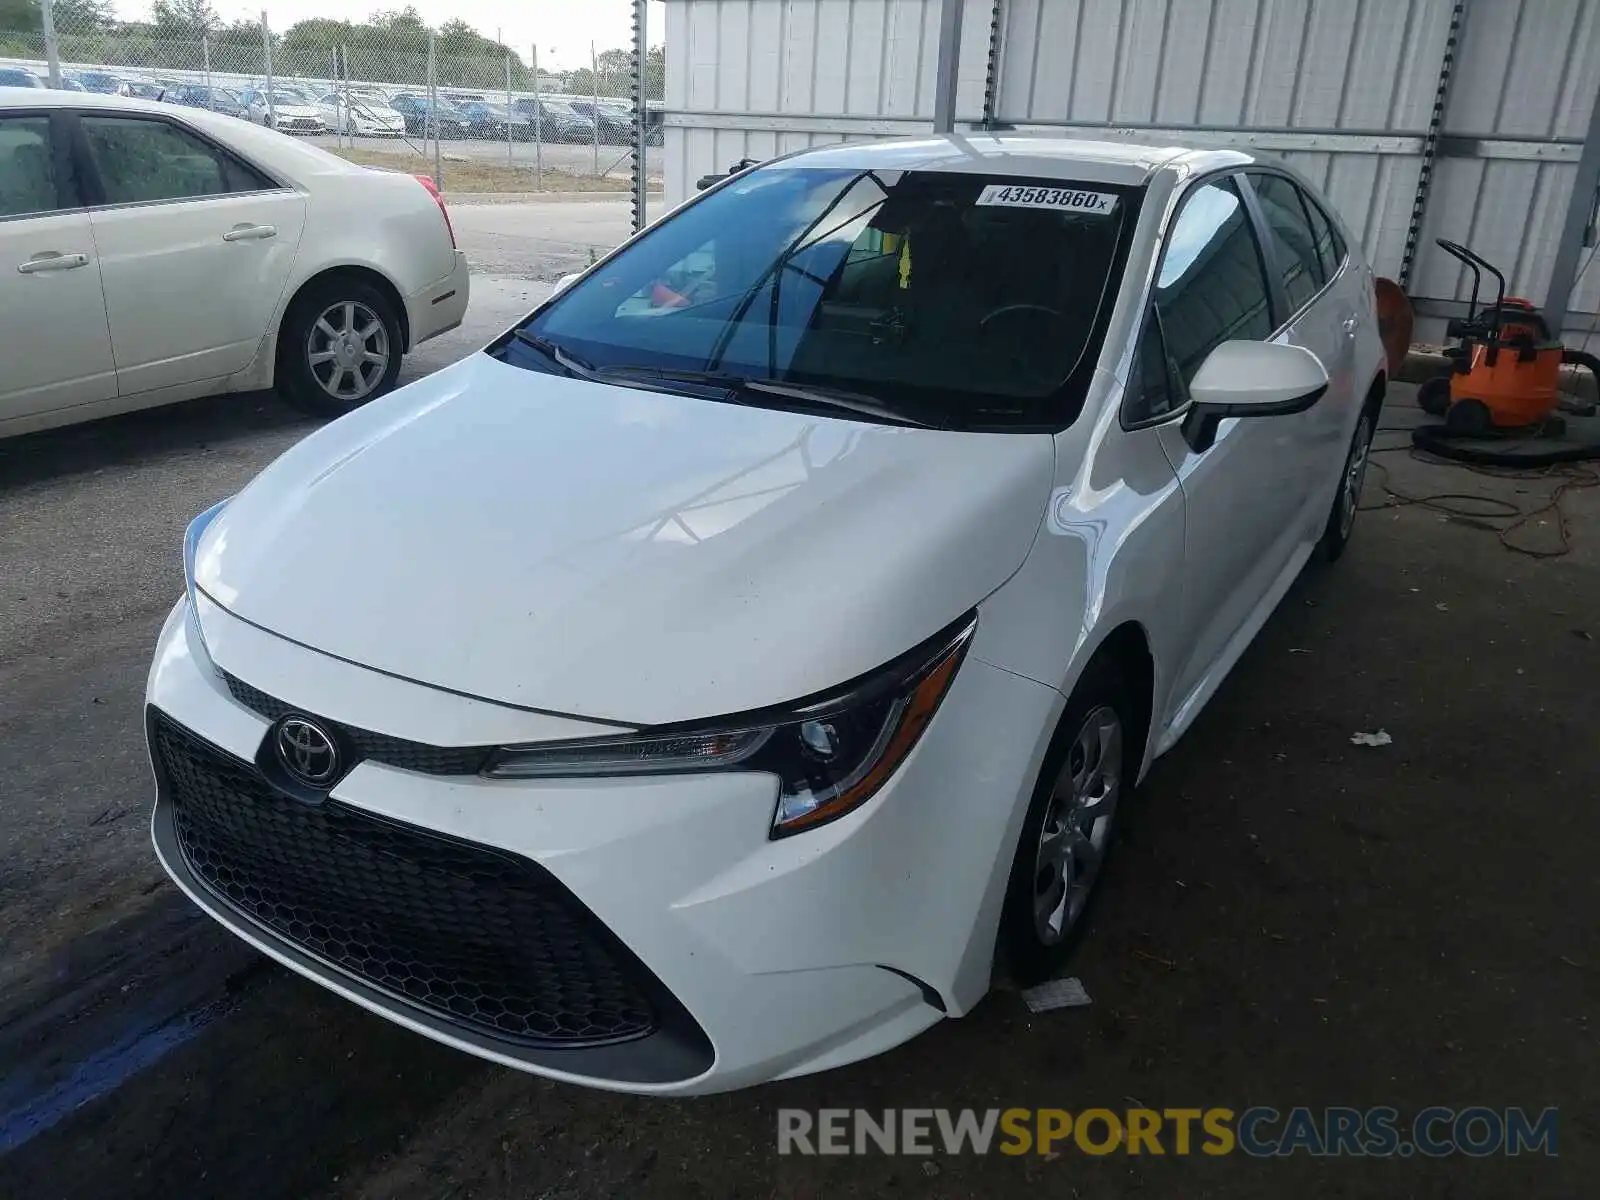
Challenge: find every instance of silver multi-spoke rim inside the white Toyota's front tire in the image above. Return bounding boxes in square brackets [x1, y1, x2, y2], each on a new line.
[1034, 706, 1123, 946]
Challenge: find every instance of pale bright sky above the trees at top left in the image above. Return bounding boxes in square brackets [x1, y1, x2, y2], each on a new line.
[115, 0, 666, 70]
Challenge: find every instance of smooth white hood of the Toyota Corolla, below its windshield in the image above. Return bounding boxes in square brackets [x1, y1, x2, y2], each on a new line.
[195, 354, 1054, 725]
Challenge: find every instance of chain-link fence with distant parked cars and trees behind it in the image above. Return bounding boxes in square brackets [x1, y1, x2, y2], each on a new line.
[0, 0, 666, 206]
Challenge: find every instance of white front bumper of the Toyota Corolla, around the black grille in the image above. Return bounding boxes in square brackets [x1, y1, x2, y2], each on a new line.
[147, 598, 1059, 1094]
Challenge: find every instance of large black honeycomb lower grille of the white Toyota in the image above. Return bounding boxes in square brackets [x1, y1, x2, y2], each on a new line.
[150, 714, 662, 1046]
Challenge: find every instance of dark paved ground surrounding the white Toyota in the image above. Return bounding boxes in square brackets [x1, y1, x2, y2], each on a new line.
[0, 205, 1600, 1200]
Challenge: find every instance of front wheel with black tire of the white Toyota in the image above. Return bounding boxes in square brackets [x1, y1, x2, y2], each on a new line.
[997, 662, 1144, 986]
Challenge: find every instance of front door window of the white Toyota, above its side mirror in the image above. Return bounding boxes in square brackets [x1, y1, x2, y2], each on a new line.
[1155, 179, 1274, 392]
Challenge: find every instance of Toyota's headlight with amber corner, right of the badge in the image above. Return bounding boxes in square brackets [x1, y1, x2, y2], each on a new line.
[485, 614, 976, 837]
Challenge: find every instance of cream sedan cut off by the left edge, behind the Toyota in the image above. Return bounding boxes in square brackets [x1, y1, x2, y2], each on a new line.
[0, 91, 469, 437]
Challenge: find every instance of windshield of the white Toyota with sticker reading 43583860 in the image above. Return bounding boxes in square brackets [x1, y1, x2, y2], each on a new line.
[504, 166, 1141, 427]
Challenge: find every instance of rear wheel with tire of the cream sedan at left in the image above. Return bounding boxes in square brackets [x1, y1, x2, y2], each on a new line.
[277, 275, 405, 416]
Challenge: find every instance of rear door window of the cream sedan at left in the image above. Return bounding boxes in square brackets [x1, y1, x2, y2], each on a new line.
[82, 117, 272, 205]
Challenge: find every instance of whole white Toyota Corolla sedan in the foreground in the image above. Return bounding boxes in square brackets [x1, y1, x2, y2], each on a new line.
[147, 136, 1386, 1093]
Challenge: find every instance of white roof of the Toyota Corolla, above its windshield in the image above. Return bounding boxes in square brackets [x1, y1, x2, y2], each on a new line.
[771, 133, 1254, 186]
